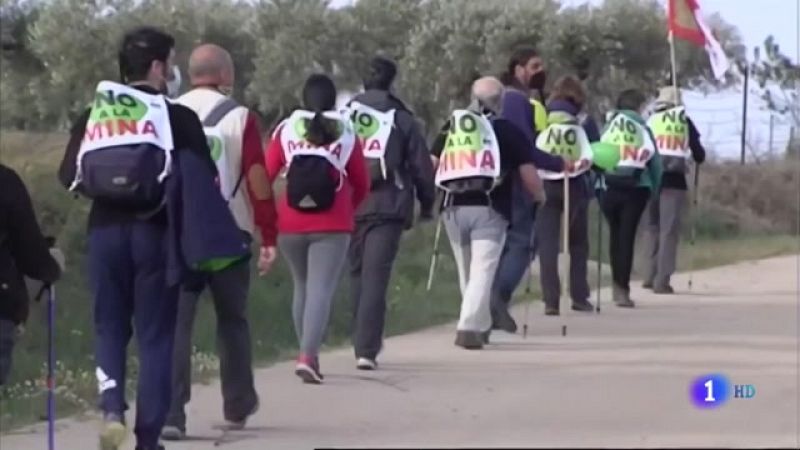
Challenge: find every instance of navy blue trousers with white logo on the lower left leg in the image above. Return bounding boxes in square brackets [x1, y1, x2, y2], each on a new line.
[89, 222, 178, 448]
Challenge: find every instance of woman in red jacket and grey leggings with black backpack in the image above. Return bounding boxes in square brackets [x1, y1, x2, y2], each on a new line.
[266, 75, 369, 384]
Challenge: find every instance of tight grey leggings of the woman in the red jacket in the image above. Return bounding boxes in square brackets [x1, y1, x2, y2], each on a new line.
[278, 233, 350, 357]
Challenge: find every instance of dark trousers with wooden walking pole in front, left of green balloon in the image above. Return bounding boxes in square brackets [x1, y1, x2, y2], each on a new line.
[536, 177, 590, 308]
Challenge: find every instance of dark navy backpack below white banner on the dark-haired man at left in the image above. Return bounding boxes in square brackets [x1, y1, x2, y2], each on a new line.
[80, 143, 167, 210]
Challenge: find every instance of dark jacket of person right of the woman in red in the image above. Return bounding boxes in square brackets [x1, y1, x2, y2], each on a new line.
[353, 90, 436, 228]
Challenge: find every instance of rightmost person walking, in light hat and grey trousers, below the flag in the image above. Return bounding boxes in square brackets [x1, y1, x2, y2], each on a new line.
[643, 86, 706, 294]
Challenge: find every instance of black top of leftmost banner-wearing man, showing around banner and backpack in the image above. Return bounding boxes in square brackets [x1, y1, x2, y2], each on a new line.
[58, 86, 217, 227]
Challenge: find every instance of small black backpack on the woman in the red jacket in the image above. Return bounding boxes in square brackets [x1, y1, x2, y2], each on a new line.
[286, 155, 342, 212]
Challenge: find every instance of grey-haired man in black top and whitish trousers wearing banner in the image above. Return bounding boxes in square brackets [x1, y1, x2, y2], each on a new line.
[432, 77, 544, 349]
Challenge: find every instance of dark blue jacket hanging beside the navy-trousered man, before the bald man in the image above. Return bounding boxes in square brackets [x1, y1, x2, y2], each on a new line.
[165, 151, 250, 286]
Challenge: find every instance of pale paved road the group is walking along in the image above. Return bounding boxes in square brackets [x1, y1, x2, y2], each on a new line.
[0, 256, 800, 450]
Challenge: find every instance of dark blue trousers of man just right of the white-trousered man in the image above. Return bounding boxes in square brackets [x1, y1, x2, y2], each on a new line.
[491, 175, 536, 317]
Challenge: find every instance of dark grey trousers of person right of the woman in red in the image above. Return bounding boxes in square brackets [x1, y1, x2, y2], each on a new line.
[349, 221, 403, 359]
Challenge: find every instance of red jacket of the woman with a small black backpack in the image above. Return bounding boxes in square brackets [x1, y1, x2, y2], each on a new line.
[266, 124, 370, 234]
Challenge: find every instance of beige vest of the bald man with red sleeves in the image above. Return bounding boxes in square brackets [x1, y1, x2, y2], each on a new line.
[177, 88, 255, 238]
